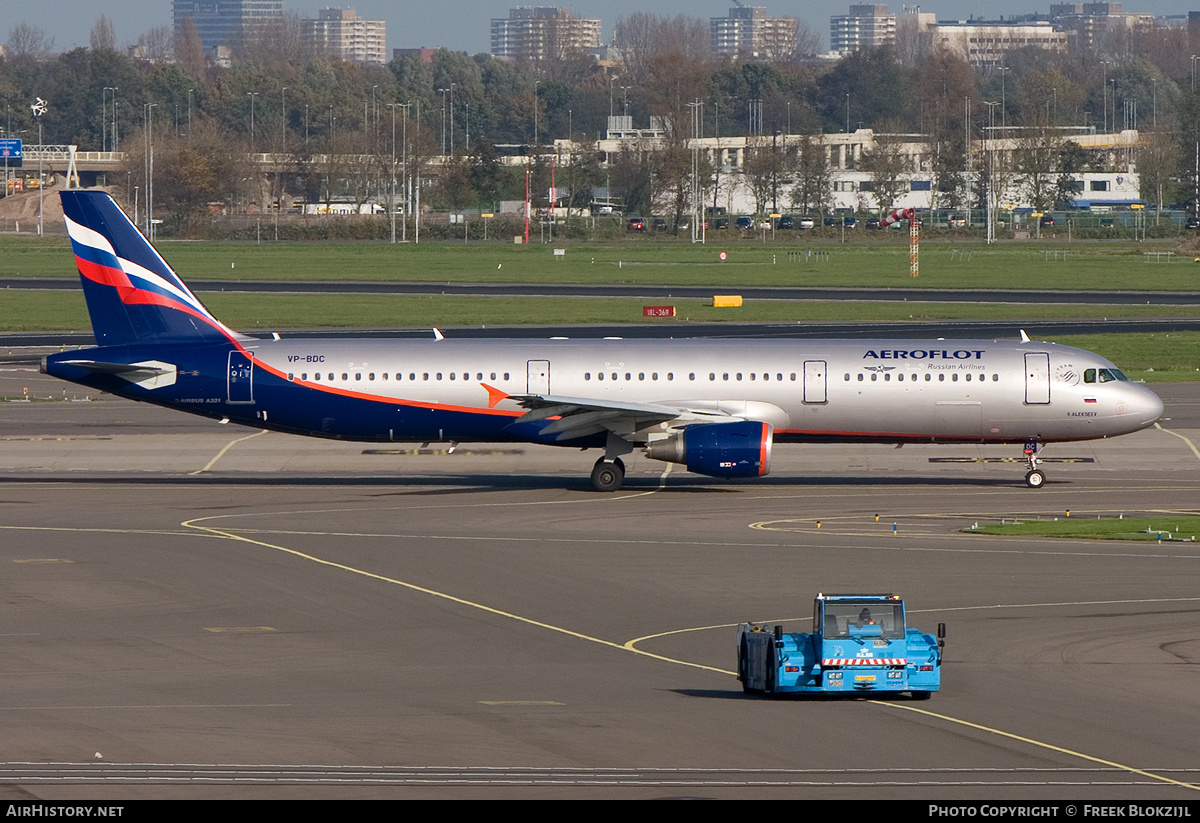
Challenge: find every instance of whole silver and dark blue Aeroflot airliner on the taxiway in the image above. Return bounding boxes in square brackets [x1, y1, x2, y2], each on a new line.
[42, 190, 1163, 492]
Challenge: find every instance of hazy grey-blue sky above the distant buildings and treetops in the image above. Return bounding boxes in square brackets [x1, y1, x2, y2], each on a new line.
[9, 0, 1200, 54]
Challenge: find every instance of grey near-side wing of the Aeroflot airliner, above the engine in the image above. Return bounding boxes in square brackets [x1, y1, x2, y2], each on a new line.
[509, 395, 730, 440]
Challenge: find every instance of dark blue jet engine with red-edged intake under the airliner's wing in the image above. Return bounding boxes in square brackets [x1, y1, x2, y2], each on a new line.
[646, 420, 775, 477]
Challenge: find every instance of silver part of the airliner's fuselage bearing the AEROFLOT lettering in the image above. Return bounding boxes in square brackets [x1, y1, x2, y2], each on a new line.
[245, 337, 1163, 443]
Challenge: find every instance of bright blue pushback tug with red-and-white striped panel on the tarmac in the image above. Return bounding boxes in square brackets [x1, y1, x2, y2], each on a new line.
[738, 594, 946, 699]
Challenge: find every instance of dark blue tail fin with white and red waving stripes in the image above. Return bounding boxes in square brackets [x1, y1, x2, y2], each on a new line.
[60, 190, 238, 346]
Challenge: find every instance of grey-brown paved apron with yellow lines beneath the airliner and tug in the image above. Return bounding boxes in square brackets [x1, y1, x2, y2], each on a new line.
[0, 368, 1200, 801]
